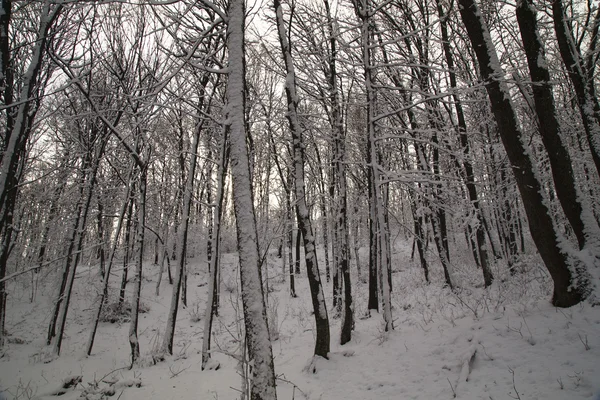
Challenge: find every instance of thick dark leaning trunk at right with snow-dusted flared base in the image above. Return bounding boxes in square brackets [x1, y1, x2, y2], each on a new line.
[459, 0, 589, 307]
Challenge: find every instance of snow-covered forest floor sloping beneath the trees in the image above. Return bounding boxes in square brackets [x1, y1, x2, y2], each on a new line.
[0, 239, 600, 400]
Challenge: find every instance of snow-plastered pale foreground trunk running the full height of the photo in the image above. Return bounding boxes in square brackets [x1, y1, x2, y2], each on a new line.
[226, 0, 277, 400]
